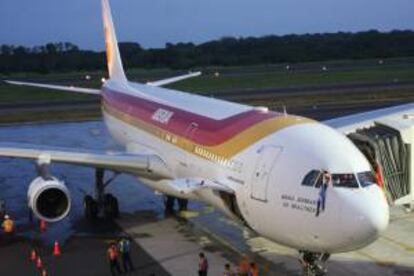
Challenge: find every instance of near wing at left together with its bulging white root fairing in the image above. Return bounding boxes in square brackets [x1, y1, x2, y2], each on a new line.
[0, 143, 234, 197]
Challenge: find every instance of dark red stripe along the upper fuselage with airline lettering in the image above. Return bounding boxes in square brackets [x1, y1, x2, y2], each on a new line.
[102, 89, 281, 146]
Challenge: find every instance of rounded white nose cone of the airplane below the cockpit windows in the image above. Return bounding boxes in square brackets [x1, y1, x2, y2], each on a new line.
[343, 185, 389, 250]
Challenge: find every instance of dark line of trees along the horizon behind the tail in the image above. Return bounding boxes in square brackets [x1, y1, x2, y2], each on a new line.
[0, 30, 414, 74]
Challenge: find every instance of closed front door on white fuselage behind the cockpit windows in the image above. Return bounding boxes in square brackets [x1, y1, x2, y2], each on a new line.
[251, 145, 282, 202]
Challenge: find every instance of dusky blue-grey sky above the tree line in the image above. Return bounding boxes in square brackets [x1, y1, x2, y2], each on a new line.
[0, 0, 414, 50]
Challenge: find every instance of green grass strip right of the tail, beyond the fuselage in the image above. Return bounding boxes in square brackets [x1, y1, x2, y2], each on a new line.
[167, 66, 414, 93]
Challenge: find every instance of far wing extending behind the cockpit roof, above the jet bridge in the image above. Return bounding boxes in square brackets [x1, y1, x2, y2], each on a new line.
[324, 103, 414, 134]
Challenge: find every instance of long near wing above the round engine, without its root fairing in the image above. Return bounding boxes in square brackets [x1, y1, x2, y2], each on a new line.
[0, 143, 170, 180]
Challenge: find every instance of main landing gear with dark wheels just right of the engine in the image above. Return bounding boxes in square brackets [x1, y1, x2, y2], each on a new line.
[83, 169, 119, 219]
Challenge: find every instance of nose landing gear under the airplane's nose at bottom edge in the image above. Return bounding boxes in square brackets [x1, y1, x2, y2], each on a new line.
[299, 251, 330, 276]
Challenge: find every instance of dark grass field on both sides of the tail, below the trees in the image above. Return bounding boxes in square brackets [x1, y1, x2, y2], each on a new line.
[0, 58, 414, 105]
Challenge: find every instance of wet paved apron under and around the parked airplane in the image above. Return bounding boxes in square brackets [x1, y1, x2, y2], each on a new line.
[0, 118, 414, 275]
